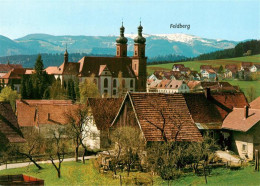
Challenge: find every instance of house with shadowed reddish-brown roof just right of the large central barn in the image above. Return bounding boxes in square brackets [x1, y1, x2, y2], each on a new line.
[183, 88, 248, 141]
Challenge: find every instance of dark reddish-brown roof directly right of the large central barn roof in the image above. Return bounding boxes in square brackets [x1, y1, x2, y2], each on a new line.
[183, 92, 248, 127]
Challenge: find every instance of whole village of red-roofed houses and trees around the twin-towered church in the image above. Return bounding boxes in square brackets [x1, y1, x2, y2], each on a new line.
[0, 22, 260, 184]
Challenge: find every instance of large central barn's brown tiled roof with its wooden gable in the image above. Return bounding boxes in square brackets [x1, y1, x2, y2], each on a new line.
[111, 92, 202, 143]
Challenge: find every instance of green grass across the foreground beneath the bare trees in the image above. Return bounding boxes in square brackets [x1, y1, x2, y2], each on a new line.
[0, 160, 260, 185]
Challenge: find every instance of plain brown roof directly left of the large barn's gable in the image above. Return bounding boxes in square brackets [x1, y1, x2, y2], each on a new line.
[88, 98, 123, 130]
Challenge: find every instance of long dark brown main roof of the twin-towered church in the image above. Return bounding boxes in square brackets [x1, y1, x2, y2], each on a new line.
[79, 56, 135, 78]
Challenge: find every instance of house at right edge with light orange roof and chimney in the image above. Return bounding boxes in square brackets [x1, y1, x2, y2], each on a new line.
[222, 97, 260, 160]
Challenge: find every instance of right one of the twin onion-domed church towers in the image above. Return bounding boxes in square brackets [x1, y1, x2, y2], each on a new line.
[132, 21, 147, 92]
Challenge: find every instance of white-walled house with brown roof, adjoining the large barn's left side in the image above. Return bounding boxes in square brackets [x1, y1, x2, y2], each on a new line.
[83, 98, 123, 150]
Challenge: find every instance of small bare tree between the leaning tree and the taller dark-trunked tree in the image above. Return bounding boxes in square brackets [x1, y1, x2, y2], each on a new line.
[47, 128, 68, 178]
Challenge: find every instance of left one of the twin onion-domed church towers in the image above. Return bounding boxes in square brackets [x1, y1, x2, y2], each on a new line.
[116, 22, 128, 57]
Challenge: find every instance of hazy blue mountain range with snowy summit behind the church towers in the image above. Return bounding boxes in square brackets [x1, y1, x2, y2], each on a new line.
[0, 34, 240, 57]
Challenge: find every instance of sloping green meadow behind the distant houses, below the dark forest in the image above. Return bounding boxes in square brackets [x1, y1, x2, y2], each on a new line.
[147, 55, 260, 74]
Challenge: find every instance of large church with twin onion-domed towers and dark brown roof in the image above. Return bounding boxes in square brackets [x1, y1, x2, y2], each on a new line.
[46, 22, 147, 97]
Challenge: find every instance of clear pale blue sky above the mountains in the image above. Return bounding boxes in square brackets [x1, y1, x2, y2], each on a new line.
[0, 0, 260, 41]
